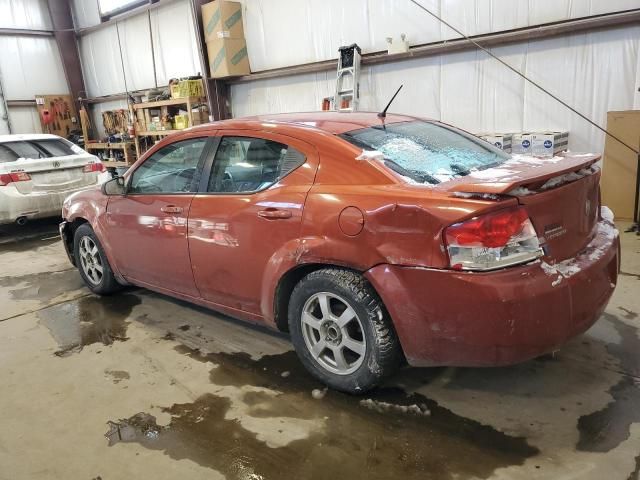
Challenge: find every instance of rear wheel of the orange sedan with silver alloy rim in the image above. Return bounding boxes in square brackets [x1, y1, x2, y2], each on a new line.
[288, 268, 401, 393]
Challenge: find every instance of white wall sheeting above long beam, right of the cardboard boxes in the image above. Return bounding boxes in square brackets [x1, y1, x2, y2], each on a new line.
[242, 0, 640, 71]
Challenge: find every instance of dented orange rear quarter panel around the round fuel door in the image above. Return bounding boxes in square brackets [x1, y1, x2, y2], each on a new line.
[298, 137, 517, 271]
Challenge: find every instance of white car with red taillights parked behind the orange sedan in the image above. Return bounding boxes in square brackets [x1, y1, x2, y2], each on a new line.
[0, 134, 110, 225]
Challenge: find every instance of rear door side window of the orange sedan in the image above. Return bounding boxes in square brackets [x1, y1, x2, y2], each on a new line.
[208, 137, 305, 193]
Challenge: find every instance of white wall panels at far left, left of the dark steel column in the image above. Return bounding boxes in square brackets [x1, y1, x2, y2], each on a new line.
[0, 0, 69, 133]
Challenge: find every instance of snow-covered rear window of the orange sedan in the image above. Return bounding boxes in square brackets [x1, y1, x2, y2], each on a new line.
[340, 120, 509, 184]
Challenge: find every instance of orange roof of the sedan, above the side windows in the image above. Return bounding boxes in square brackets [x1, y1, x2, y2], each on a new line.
[188, 111, 418, 135]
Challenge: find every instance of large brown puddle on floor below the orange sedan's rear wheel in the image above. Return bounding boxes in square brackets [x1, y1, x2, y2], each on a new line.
[106, 346, 538, 480]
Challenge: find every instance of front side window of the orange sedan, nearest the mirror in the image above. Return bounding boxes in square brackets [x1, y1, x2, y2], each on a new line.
[128, 138, 207, 193]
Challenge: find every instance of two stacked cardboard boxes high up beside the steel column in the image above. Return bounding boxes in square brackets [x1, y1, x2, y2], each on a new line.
[202, 0, 251, 78]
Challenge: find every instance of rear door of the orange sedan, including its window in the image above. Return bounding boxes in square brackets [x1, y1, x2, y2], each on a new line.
[189, 131, 318, 315]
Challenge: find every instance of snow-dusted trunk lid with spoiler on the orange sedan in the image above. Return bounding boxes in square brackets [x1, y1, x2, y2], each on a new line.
[436, 154, 600, 261]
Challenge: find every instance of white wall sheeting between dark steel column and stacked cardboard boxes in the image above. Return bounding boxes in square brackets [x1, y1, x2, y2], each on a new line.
[76, 0, 200, 97]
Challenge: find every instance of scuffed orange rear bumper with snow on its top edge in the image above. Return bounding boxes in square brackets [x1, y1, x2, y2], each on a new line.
[366, 220, 620, 366]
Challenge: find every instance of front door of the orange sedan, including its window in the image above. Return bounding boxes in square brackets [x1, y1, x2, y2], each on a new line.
[106, 133, 207, 297]
